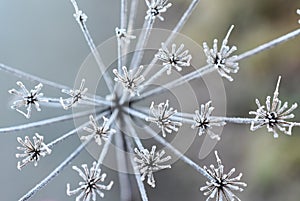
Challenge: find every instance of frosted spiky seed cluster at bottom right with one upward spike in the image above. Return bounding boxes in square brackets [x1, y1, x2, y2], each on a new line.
[200, 151, 247, 201]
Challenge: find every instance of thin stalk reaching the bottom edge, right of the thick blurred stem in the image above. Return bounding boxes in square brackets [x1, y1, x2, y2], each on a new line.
[126, 136, 148, 201]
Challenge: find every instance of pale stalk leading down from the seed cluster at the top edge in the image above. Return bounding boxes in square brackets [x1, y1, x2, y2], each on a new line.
[130, 18, 155, 68]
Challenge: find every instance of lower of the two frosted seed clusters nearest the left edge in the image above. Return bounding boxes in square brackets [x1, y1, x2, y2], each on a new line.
[16, 133, 51, 170]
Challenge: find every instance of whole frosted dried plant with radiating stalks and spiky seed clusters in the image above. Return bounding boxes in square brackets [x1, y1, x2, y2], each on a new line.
[0, 0, 300, 201]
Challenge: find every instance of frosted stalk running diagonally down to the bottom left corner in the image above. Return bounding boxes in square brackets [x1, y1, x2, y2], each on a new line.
[19, 136, 94, 201]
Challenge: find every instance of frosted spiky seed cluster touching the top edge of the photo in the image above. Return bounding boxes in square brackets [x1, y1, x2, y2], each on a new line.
[145, 0, 172, 21]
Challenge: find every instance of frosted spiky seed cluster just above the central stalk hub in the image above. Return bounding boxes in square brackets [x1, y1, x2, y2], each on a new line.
[113, 66, 145, 96]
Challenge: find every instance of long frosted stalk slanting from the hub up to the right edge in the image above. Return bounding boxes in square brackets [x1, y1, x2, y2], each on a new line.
[132, 29, 300, 102]
